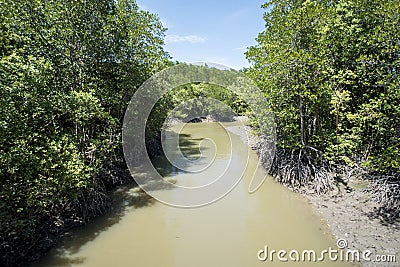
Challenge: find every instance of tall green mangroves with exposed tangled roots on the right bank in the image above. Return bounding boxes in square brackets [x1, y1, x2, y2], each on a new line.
[246, 0, 400, 216]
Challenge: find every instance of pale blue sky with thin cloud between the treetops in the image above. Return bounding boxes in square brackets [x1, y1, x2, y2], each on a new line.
[137, 0, 266, 69]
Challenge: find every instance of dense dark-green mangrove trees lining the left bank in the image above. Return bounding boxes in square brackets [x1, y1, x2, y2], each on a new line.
[0, 0, 170, 266]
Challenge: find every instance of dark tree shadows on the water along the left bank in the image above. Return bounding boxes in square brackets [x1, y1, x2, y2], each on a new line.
[33, 132, 209, 267]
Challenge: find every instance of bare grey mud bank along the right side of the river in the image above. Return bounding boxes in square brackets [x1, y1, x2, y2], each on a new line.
[228, 117, 400, 267]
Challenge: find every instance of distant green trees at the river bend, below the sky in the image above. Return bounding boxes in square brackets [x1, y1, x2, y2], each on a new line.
[145, 63, 257, 151]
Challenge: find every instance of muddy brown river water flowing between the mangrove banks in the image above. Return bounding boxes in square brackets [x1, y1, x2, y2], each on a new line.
[34, 123, 350, 267]
